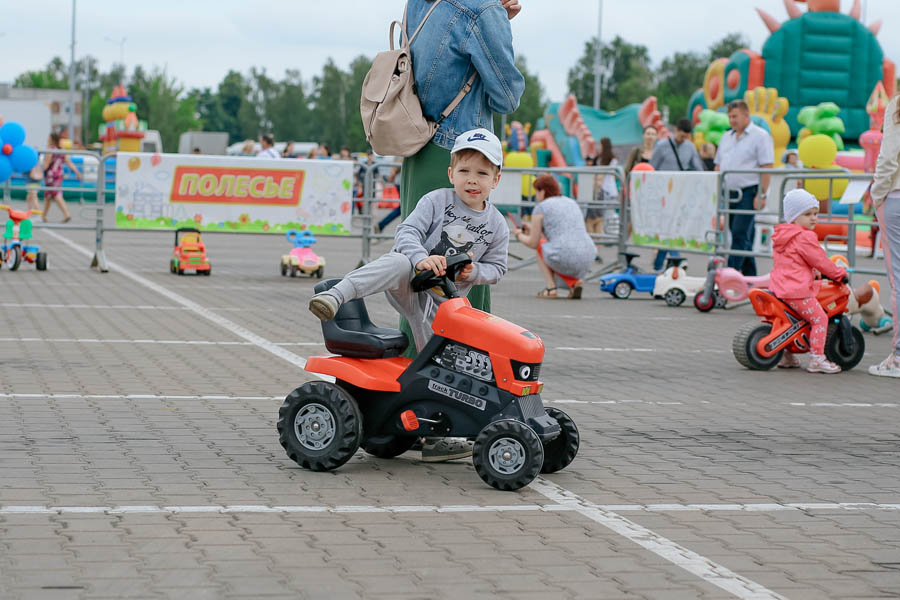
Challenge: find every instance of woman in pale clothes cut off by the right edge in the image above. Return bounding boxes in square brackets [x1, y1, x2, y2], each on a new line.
[869, 95, 900, 377]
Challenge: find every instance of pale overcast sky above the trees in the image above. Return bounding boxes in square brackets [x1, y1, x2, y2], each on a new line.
[0, 0, 900, 101]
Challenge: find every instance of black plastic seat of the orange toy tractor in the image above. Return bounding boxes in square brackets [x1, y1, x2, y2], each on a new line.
[314, 279, 409, 358]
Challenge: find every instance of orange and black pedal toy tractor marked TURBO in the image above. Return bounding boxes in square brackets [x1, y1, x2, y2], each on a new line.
[278, 254, 579, 490]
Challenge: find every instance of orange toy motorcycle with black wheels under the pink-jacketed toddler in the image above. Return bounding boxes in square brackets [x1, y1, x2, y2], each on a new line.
[731, 281, 866, 371]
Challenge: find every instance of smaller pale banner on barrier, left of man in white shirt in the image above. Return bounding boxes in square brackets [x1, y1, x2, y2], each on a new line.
[629, 171, 719, 250]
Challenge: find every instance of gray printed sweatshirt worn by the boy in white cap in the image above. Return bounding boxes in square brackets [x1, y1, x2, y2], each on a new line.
[394, 188, 509, 292]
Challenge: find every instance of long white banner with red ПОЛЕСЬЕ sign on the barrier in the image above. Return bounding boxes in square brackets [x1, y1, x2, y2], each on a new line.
[116, 152, 353, 235]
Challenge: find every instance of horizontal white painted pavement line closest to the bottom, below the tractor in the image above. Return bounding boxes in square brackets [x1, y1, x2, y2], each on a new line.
[0, 502, 900, 516]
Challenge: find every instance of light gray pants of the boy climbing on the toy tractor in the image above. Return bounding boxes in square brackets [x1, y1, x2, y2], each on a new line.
[332, 252, 438, 352]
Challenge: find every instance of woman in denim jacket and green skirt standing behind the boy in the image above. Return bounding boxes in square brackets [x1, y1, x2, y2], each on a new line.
[400, 0, 525, 336]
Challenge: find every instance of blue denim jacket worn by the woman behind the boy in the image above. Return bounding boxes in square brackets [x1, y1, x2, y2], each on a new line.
[407, 0, 525, 149]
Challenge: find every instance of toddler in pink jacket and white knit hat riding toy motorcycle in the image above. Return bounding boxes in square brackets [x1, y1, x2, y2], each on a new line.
[769, 189, 847, 373]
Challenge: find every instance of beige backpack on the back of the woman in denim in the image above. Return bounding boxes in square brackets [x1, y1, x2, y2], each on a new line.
[359, 0, 477, 156]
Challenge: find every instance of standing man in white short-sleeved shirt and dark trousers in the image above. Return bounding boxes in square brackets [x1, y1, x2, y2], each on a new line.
[716, 100, 774, 275]
